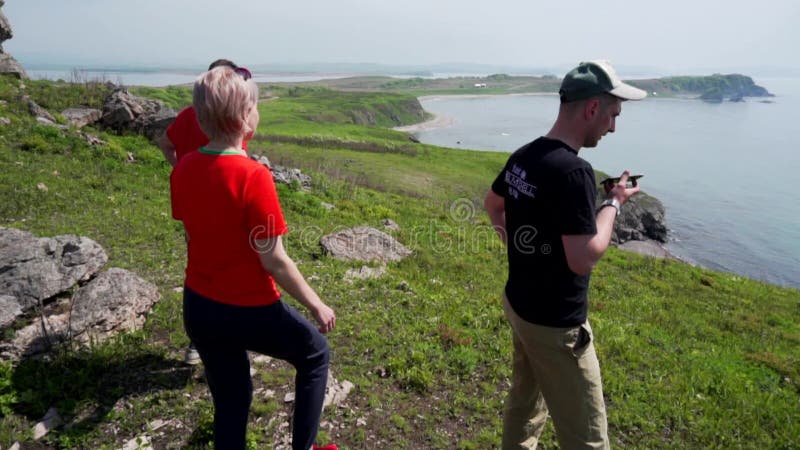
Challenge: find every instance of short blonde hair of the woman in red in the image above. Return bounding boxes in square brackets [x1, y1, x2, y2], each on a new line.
[192, 66, 258, 140]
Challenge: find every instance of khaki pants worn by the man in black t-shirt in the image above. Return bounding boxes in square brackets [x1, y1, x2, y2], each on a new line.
[502, 295, 610, 450]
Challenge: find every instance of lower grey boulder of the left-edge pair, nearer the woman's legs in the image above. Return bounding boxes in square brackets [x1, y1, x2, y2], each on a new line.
[0, 268, 161, 359]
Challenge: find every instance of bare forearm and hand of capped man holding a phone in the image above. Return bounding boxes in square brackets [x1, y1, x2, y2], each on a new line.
[561, 170, 639, 275]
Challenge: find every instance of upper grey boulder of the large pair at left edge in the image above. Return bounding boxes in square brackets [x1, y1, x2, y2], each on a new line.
[0, 227, 108, 311]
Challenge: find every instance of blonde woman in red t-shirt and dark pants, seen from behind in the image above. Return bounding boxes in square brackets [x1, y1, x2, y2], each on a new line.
[170, 67, 336, 450]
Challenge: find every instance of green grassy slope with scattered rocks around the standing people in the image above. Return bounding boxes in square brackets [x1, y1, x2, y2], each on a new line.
[0, 77, 800, 449]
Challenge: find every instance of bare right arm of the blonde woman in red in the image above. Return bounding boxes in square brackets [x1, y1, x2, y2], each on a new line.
[255, 236, 336, 333]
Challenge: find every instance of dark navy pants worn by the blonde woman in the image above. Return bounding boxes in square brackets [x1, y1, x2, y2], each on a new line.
[183, 287, 330, 450]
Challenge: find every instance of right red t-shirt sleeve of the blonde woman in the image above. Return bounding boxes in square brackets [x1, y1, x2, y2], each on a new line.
[244, 166, 288, 239]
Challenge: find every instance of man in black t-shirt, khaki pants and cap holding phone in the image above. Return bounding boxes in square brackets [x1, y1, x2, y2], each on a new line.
[484, 61, 646, 450]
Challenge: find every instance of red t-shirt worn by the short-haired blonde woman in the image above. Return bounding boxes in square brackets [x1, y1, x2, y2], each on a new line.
[170, 148, 287, 306]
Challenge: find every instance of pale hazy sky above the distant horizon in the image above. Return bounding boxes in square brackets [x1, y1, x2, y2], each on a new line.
[3, 0, 800, 72]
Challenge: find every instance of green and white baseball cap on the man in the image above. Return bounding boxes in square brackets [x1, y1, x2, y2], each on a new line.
[558, 60, 647, 102]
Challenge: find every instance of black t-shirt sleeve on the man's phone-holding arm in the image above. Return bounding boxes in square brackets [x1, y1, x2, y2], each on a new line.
[556, 168, 597, 235]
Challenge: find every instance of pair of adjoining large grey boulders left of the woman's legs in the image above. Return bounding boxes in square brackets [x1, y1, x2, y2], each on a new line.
[0, 228, 160, 359]
